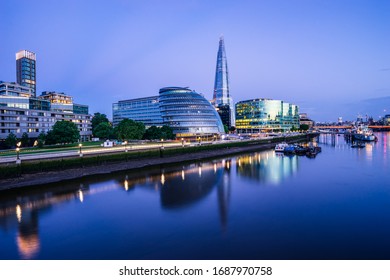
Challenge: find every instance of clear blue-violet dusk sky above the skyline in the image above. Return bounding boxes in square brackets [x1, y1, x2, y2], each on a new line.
[0, 0, 390, 122]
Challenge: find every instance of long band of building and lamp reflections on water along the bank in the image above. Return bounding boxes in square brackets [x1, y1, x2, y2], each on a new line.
[0, 147, 310, 259]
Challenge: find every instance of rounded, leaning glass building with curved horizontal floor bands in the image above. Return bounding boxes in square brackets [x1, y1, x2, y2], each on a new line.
[159, 87, 224, 138]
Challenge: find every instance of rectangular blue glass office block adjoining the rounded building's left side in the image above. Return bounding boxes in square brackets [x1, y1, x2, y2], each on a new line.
[112, 96, 163, 127]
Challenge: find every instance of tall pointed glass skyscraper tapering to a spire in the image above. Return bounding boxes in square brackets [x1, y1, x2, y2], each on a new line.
[213, 36, 235, 127]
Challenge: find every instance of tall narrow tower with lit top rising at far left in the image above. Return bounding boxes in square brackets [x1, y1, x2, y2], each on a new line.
[16, 50, 37, 97]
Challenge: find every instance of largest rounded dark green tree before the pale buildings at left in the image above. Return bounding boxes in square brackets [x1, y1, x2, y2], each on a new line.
[46, 121, 80, 144]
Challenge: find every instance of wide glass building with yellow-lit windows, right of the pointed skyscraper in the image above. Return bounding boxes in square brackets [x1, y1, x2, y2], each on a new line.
[236, 99, 299, 133]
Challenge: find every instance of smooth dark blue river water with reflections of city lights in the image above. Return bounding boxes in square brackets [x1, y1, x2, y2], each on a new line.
[0, 133, 390, 259]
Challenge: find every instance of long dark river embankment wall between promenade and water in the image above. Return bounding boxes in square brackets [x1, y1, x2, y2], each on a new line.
[0, 134, 316, 191]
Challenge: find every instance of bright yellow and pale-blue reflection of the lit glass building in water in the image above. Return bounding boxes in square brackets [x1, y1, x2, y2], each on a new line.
[236, 151, 298, 184]
